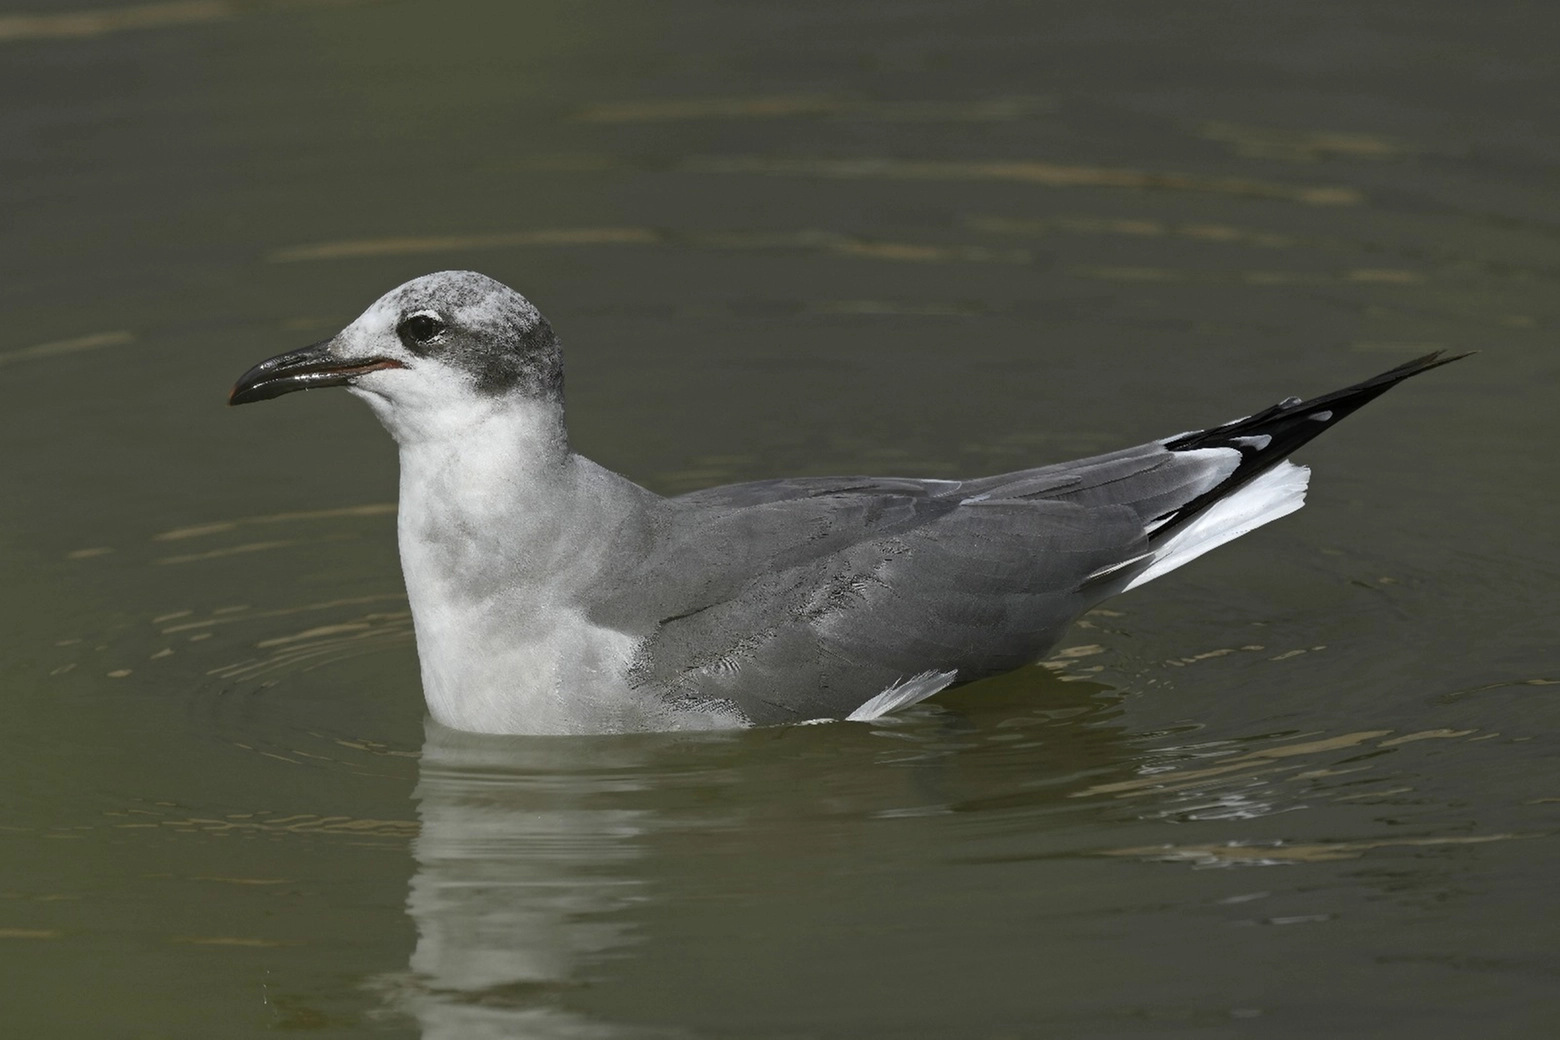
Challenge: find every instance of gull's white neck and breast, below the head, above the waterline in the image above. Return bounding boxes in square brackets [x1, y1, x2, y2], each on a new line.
[382, 405, 746, 733]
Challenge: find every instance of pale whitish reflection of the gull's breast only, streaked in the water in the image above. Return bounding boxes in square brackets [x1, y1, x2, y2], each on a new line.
[381, 720, 686, 1040]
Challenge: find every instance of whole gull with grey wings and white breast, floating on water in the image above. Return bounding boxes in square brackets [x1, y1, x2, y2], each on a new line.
[229, 271, 1460, 733]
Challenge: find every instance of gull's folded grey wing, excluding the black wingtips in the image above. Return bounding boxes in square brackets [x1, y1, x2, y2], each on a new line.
[608, 443, 1234, 723]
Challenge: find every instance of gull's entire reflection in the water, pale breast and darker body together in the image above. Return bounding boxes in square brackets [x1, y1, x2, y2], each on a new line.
[378, 675, 1123, 1040]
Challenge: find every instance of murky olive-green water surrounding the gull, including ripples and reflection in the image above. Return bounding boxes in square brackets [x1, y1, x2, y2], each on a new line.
[0, 0, 1560, 1038]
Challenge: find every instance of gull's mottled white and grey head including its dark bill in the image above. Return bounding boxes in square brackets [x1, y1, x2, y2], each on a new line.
[231, 271, 563, 444]
